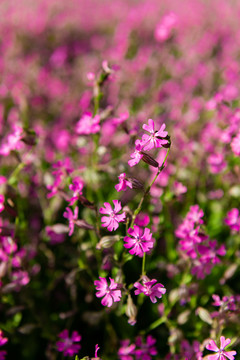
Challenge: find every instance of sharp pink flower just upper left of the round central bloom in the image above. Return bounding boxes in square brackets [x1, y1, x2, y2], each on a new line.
[99, 200, 126, 231]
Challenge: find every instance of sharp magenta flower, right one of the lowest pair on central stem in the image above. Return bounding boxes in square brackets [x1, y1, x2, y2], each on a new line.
[134, 276, 166, 303]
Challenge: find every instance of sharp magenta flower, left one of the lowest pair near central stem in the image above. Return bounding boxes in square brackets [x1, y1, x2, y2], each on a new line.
[94, 277, 122, 307]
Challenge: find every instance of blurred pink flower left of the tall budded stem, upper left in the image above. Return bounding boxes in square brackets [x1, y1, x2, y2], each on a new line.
[76, 112, 100, 135]
